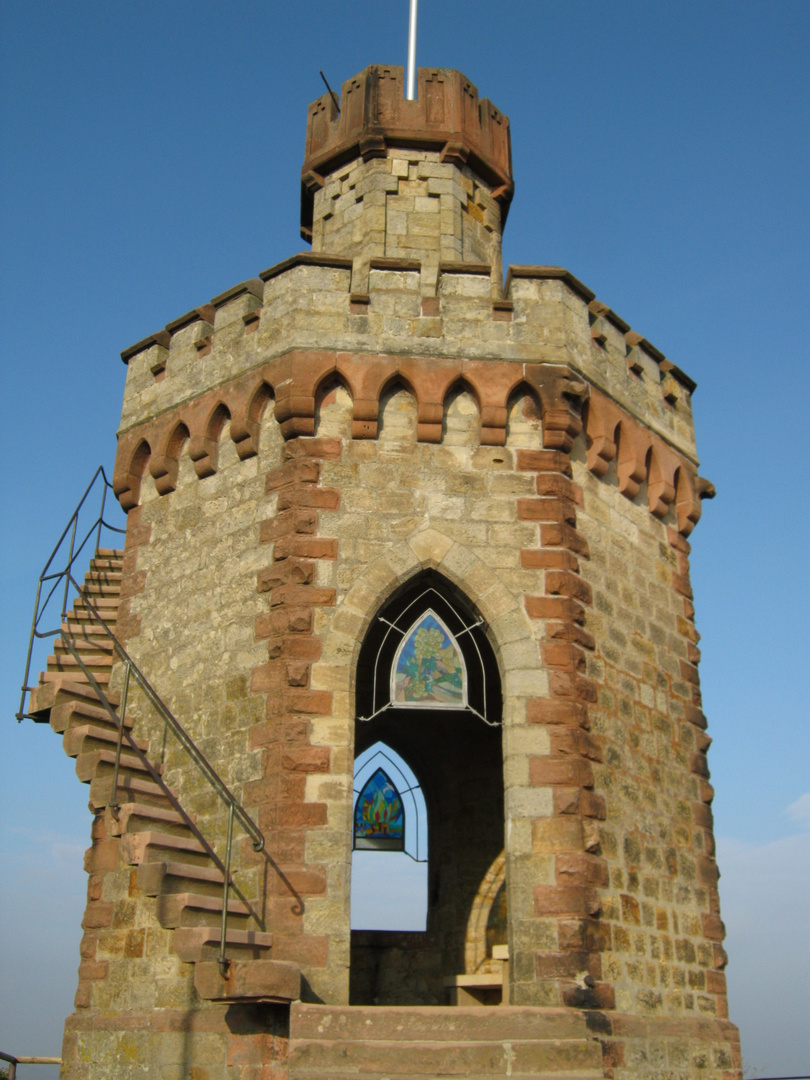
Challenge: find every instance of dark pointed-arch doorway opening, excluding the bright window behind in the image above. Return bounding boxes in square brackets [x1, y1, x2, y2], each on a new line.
[351, 571, 504, 1004]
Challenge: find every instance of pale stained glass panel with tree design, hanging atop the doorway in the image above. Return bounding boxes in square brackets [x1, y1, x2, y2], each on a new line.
[391, 611, 467, 708]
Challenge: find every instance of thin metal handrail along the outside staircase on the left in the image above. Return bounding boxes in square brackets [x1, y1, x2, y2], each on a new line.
[17, 467, 265, 977]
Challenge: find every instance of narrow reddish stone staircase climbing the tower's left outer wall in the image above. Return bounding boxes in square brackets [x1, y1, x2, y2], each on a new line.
[28, 549, 300, 1001]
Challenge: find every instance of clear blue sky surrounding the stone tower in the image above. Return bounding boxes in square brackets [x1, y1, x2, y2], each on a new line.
[0, 0, 810, 1080]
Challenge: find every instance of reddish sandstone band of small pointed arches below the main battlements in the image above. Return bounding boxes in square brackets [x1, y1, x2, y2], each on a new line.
[116, 349, 713, 536]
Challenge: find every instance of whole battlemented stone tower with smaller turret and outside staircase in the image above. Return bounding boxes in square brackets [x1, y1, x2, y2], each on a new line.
[30, 67, 741, 1080]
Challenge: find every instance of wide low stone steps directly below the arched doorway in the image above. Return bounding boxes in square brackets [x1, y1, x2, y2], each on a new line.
[287, 1002, 604, 1080]
